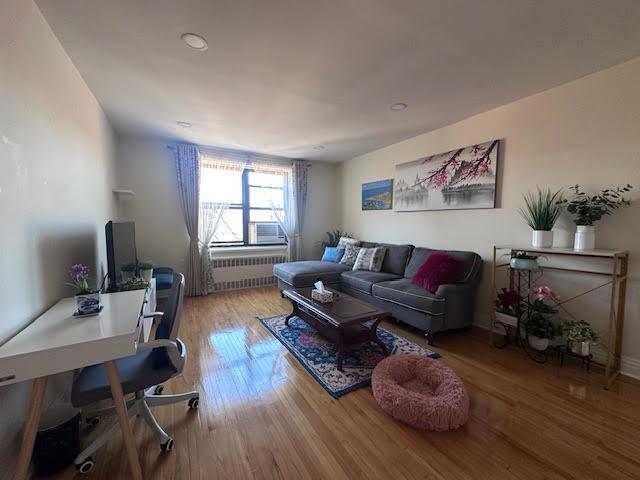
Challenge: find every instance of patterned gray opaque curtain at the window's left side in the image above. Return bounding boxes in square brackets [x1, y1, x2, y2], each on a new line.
[173, 144, 202, 296]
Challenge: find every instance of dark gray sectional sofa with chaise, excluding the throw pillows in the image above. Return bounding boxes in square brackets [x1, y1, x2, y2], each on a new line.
[273, 242, 482, 343]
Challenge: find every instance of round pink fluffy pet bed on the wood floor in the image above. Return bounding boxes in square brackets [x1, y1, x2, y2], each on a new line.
[371, 355, 469, 432]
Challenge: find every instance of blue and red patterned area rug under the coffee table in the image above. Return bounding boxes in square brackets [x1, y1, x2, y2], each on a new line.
[259, 315, 440, 398]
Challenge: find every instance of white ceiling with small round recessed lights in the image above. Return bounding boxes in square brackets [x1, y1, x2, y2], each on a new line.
[37, 0, 640, 161]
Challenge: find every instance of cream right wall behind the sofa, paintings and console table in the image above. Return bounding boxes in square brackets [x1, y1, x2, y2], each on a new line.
[341, 59, 640, 373]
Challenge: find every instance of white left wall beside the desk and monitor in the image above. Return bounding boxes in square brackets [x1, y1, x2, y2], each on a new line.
[0, 0, 114, 478]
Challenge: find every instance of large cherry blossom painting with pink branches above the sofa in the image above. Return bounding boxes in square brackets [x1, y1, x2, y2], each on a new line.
[393, 140, 499, 212]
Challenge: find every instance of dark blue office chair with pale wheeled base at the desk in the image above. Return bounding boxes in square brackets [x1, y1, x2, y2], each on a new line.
[71, 273, 199, 473]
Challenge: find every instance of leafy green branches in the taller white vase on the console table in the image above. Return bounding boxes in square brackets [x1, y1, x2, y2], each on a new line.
[558, 184, 633, 226]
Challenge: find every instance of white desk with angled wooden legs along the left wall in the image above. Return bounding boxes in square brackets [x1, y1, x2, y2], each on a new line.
[0, 283, 155, 479]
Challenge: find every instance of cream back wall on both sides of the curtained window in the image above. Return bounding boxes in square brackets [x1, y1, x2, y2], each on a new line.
[117, 137, 340, 271]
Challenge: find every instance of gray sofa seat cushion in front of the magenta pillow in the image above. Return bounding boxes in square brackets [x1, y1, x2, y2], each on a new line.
[371, 278, 445, 315]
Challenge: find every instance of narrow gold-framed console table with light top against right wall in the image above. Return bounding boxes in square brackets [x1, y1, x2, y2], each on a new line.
[489, 245, 629, 389]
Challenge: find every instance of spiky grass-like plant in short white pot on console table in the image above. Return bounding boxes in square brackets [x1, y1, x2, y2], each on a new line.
[520, 188, 562, 248]
